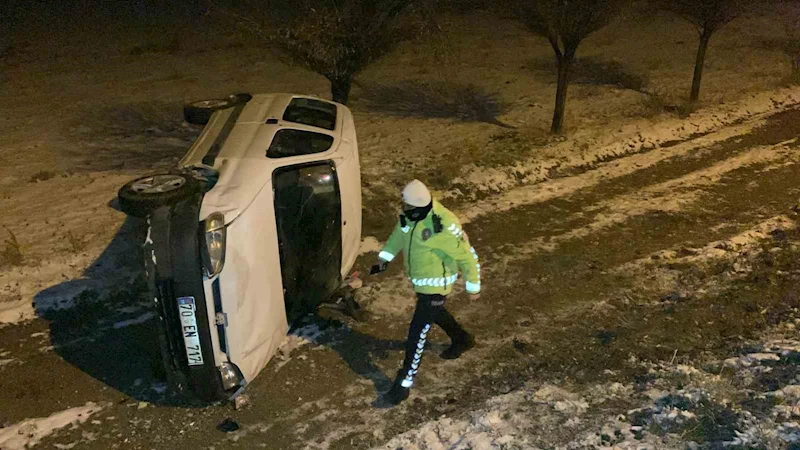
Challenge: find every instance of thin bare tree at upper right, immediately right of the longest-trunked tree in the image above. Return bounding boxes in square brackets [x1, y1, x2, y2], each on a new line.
[662, 0, 746, 104]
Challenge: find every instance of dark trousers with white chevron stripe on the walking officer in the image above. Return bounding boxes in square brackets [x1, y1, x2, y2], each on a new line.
[397, 294, 468, 388]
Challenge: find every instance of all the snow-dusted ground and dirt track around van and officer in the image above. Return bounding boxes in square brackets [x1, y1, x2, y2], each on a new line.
[0, 3, 800, 450]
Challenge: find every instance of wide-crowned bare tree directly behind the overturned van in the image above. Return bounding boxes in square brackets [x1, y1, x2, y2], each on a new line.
[219, 0, 413, 103]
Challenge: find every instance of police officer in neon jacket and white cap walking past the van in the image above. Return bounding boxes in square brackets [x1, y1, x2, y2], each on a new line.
[372, 180, 481, 405]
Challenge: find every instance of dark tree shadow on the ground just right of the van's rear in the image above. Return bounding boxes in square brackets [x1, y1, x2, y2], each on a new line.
[356, 81, 511, 128]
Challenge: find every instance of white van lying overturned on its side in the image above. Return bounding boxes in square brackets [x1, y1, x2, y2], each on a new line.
[118, 94, 361, 401]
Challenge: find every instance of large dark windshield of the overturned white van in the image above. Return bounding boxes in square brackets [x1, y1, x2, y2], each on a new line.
[272, 161, 342, 324]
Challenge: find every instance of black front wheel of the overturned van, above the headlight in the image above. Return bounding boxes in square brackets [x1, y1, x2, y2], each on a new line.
[117, 173, 201, 217]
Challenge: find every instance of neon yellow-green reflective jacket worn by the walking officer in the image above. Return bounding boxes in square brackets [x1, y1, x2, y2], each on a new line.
[378, 200, 481, 295]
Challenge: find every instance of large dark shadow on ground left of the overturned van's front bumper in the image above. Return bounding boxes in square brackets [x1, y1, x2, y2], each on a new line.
[35, 213, 198, 405]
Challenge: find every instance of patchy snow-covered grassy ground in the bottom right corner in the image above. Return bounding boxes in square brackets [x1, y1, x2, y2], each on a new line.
[376, 332, 800, 450]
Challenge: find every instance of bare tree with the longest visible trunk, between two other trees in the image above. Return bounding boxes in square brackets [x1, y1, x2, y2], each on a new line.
[509, 0, 623, 134]
